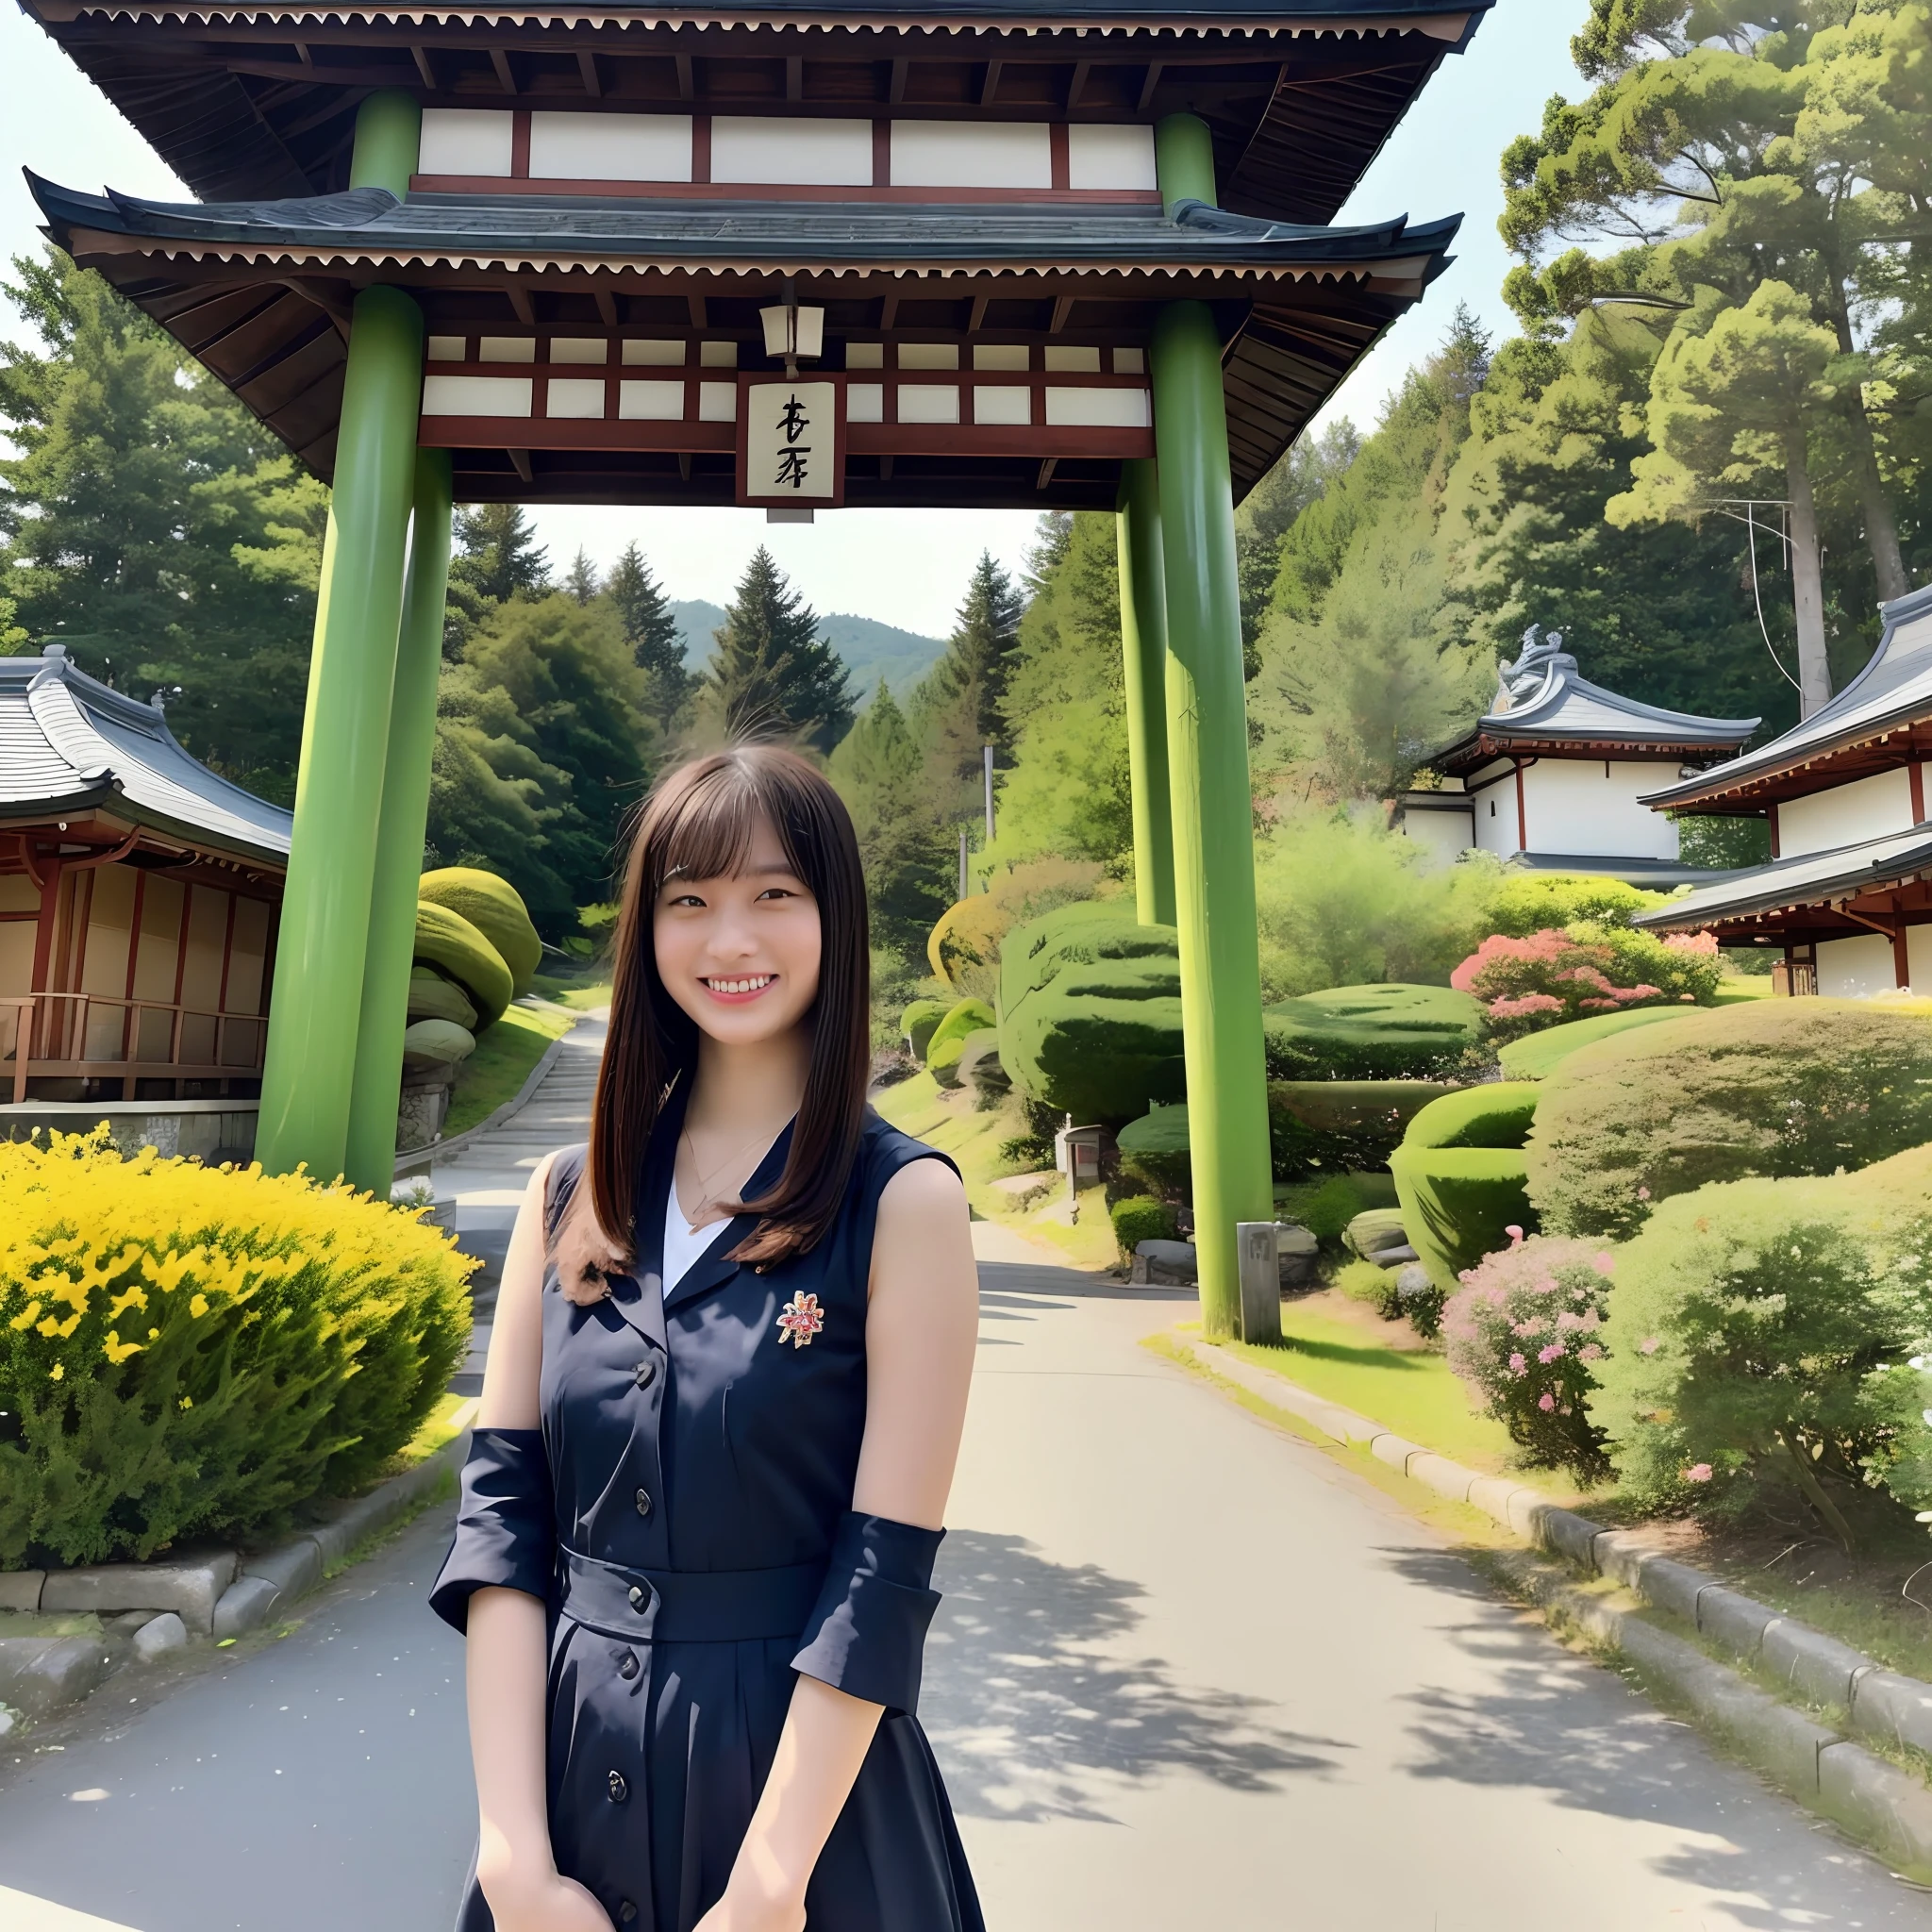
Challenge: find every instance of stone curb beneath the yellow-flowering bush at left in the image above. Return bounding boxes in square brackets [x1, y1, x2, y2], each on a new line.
[0, 1430, 470, 1718]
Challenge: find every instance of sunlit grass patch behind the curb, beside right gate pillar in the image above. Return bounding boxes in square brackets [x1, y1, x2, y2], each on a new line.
[1223, 1302, 1578, 1501]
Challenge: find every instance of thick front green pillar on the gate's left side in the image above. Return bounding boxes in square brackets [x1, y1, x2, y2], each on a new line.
[255, 92, 424, 1180]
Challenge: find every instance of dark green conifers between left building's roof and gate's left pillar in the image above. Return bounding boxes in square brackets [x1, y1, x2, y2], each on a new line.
[0, 251, 328, 800]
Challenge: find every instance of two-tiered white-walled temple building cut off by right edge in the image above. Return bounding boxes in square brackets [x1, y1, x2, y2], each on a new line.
[1639, 590, 1932, 999]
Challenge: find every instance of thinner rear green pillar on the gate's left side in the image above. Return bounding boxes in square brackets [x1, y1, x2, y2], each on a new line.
[344, 450, 452, 1200]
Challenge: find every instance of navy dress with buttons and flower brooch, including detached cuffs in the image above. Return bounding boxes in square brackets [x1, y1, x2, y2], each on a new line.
[431, 1093, 983, 1932]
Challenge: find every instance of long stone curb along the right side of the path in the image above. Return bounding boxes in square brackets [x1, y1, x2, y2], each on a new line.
[1186, 1342, 1932, 1876]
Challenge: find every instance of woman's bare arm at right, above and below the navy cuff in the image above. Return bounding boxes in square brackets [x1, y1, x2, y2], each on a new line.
[697, 1161, 979, 1932]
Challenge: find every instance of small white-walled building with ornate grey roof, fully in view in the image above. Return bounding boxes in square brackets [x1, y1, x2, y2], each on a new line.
[1401, 625, 1760, 889]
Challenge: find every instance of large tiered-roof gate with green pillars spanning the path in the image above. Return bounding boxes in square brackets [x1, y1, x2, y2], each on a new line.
[24, 0, 1491, 1329]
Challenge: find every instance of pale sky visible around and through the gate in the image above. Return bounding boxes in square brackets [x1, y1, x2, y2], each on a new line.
[0, 0, 1588, 636]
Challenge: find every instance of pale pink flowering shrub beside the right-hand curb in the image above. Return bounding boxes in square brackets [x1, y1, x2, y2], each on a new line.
[1443, 1229, 1613, 1484]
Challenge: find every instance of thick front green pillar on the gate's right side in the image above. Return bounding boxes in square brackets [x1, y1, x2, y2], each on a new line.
[1152, 114, 1274, 1335]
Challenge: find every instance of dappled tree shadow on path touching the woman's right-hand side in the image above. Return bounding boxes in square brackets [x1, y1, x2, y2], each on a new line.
[920, 1530, 1342, 1822]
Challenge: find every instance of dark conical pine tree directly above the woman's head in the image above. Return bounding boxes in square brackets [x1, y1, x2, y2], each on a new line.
[699, 545, 852, 752]
